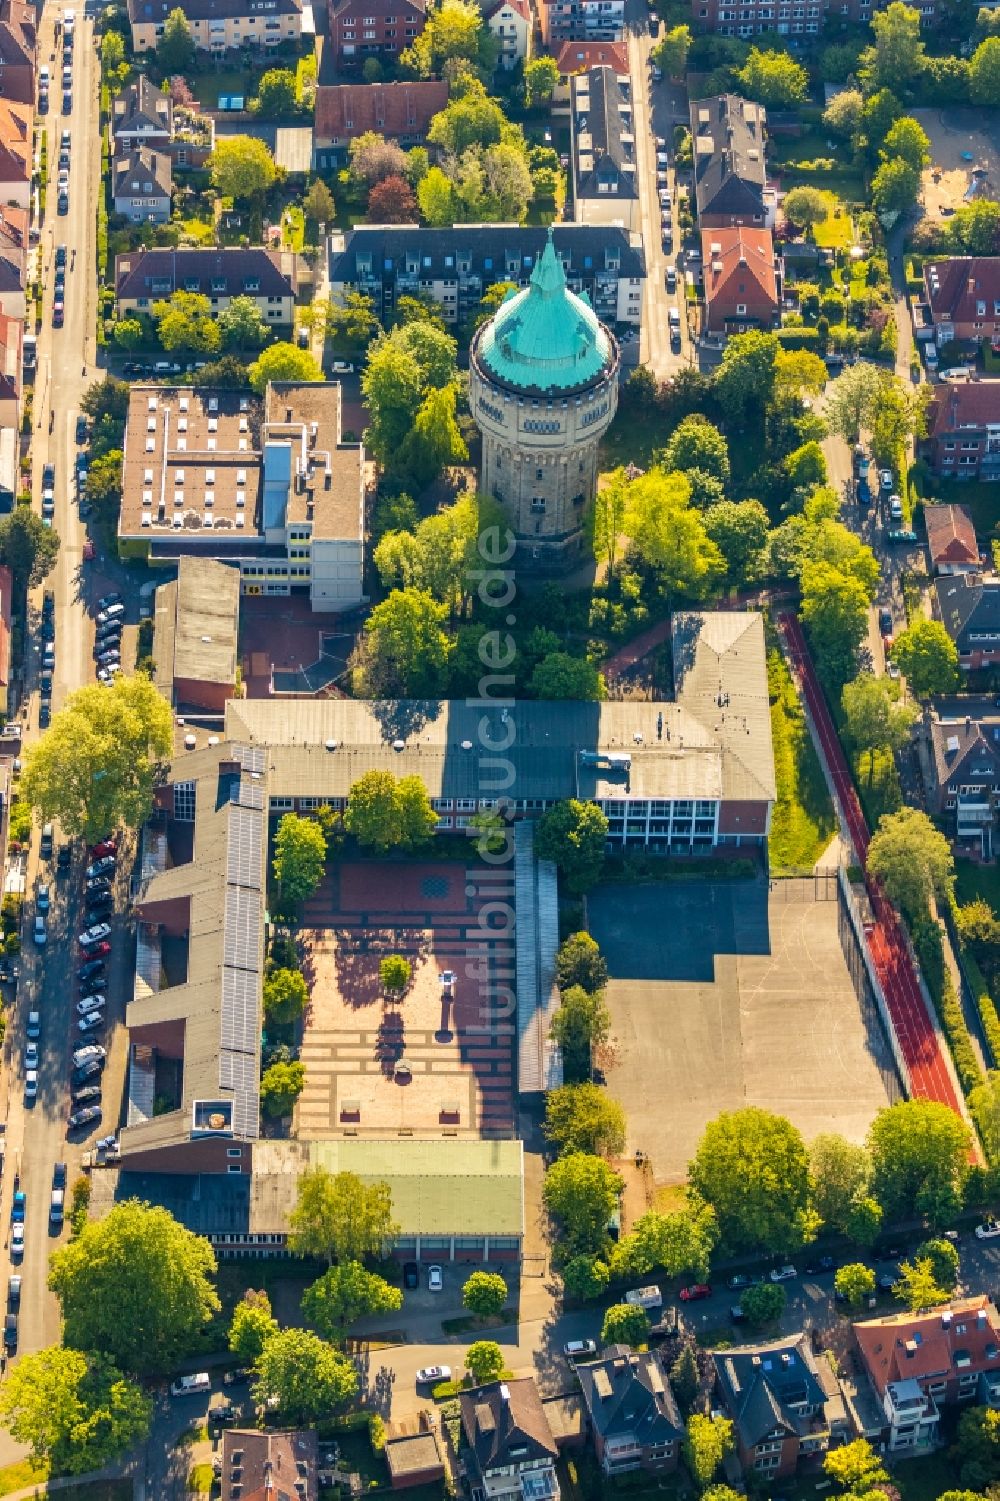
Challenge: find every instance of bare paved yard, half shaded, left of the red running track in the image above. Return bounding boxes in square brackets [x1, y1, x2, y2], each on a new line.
[589, 880, 887, 1183]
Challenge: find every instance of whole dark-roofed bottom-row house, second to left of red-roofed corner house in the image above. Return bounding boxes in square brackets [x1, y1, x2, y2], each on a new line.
[577, 1345, 685, 1475]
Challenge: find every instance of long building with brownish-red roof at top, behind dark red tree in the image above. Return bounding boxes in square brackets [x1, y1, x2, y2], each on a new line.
[312, 78, 447, 171]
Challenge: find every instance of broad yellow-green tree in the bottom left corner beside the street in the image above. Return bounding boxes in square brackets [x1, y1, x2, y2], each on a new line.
[0, 1345, 153, 1475]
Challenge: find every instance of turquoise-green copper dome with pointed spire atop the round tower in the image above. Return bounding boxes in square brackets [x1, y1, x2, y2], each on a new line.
[479, 230, 613, 392]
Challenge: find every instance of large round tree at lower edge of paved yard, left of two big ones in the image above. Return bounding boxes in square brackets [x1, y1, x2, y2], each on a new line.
[688, 1106, 814, 1252]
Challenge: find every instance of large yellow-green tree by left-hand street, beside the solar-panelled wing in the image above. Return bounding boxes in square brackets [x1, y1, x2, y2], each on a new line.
[21, 672, 173, 844]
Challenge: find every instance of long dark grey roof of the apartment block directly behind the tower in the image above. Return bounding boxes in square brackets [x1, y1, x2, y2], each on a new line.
[322, 224, 646, 287]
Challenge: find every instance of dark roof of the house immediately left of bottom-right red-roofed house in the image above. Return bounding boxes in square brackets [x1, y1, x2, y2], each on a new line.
[712, 1334, 826, 1448]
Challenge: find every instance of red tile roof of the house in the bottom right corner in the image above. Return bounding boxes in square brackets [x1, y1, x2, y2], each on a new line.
[854, 1294, 1000, 1396]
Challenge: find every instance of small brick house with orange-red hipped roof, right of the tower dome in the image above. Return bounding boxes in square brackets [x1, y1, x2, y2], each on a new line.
[701, 225, 781, 335]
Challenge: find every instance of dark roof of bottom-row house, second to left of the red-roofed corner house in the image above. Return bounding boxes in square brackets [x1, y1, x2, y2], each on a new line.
[577, 1345, 685, 1447]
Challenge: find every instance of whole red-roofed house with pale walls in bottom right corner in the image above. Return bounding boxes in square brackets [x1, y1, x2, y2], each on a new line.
[854, 1294, 1000, 1453]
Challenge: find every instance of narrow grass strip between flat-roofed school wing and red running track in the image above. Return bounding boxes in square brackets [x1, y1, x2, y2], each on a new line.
[767, 647, 836, 875]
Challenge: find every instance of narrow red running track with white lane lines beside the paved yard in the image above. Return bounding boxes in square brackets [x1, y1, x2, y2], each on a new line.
[779, 614, 961, 1114]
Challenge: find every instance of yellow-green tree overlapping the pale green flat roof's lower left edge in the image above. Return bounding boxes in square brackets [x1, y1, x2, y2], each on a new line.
[288, 1168, 399, 1265]
